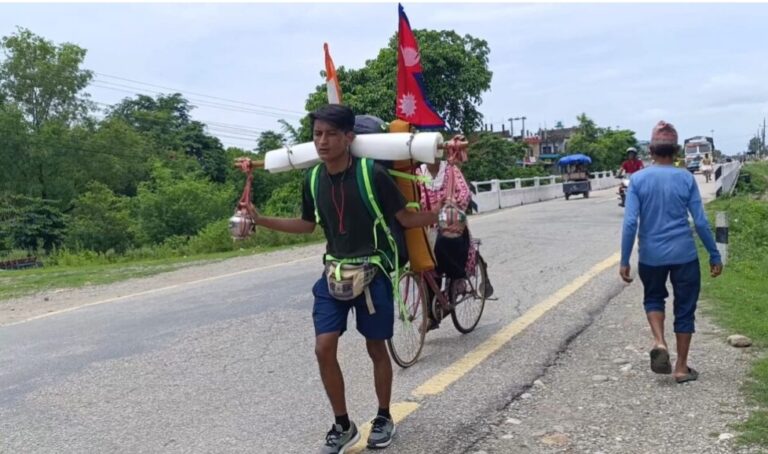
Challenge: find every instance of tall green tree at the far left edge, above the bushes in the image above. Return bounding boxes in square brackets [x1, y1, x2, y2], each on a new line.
[0, 28, 100, 205]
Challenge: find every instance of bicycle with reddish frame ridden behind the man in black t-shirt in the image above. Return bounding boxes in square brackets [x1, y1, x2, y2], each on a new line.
[387, 239, 491, 368]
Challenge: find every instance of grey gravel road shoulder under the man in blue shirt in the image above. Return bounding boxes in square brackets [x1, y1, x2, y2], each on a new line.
[467, 282, 755, 454]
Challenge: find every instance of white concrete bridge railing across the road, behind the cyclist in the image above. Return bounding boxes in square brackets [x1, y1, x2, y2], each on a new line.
[471, 171, 620, 213]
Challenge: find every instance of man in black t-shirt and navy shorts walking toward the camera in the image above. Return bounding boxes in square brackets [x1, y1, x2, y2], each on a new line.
[247, 104, 437, 454]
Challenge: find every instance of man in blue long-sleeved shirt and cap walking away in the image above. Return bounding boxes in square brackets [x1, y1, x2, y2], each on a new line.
[619, 121, 723, 383]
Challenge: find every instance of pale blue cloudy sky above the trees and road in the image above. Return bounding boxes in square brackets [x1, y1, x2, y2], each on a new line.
[0, 3, 768, 154]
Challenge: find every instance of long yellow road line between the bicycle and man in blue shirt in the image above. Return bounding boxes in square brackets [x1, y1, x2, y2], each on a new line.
[412, 253, 620, 398]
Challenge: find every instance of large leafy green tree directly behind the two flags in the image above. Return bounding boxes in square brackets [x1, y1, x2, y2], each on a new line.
[301, 30, 493, 134]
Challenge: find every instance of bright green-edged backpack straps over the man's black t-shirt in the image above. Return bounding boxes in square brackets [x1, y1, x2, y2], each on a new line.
[308, 158, 408, 274]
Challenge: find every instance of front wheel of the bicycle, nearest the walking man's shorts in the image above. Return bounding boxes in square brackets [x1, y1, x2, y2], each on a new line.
[387, 271, 428, 368]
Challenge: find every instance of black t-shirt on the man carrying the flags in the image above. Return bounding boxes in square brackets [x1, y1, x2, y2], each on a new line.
[301, 157, 405, 258]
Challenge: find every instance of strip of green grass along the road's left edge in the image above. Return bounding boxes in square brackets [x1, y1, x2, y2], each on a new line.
[0, 235, 320, 301]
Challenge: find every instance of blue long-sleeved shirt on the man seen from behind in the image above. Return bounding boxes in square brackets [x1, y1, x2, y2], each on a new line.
[621, 165, 722, 266]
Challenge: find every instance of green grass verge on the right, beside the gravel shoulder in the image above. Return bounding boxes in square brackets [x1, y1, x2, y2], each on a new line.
[702, 163, 768, 447]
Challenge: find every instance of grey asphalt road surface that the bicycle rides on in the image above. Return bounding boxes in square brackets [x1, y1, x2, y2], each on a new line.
[0, 177, 714, 453]
